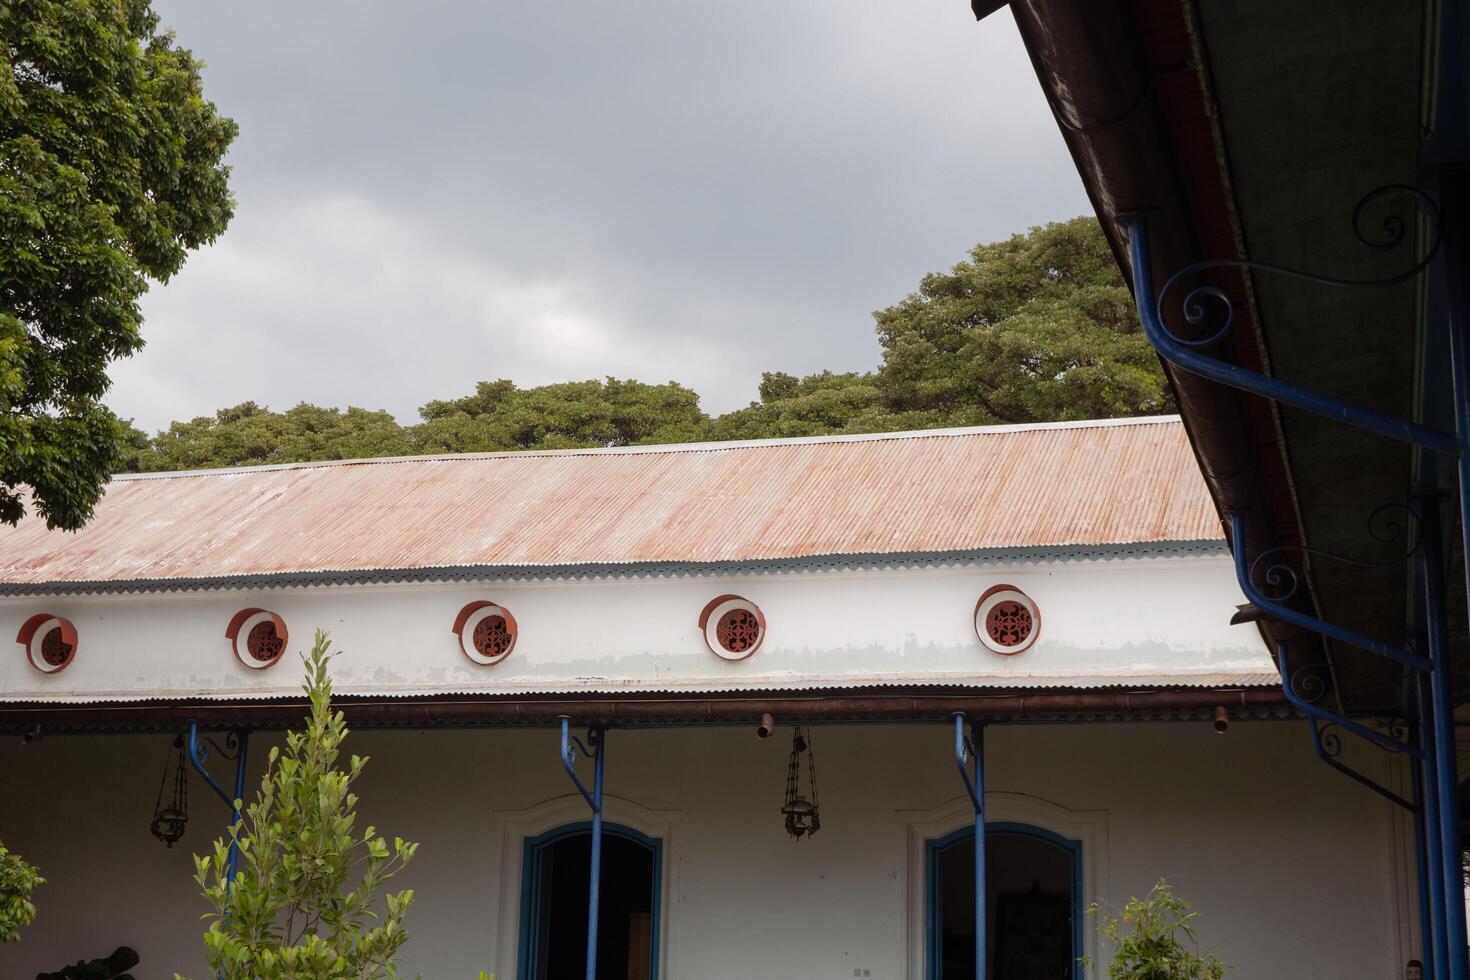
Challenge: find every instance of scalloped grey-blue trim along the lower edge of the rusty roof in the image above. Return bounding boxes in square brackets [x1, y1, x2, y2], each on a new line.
[0, 539, 1227, 598]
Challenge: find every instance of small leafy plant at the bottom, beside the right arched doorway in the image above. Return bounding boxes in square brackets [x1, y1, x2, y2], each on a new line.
[1083, 879, 1225, 980]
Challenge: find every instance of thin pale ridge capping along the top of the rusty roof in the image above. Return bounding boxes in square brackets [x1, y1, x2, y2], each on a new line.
[112, 414, 1179, 482]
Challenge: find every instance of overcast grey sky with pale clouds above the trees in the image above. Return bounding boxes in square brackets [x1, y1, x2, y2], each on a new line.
[109, 0, 1089, 430]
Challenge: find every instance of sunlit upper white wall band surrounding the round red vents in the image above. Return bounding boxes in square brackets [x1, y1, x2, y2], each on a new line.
[0, 555, 1277, 701]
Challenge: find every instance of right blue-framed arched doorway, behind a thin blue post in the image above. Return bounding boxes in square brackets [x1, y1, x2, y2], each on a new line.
[925, 823, 1082, 980]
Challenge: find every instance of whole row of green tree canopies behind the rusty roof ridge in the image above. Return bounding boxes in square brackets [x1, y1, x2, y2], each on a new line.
[114, 217, 1173, 470]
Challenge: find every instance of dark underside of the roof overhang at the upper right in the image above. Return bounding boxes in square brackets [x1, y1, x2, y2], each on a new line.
[976, 0, 1432, 710]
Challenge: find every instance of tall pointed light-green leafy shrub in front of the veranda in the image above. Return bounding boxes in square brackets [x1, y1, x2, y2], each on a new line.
[180, 630, 419, 980]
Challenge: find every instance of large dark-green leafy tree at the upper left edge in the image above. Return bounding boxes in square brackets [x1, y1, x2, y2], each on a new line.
[0, 0, 235, 527]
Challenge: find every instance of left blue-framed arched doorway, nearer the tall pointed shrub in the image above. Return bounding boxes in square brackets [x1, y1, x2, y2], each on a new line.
[517, 823, 663, 980]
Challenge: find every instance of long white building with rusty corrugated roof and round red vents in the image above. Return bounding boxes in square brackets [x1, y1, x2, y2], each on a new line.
[0, 419, 1411, 980]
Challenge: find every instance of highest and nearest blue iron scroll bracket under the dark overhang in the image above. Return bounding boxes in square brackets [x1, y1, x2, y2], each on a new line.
[1117, 205, 1460, 455]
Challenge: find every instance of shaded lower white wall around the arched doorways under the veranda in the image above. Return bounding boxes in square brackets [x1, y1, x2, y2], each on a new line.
[0, 721, 1408, 980]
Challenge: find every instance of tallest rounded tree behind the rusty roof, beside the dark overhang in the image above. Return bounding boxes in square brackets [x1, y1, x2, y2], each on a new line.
[875, 217, 1172, 425]
